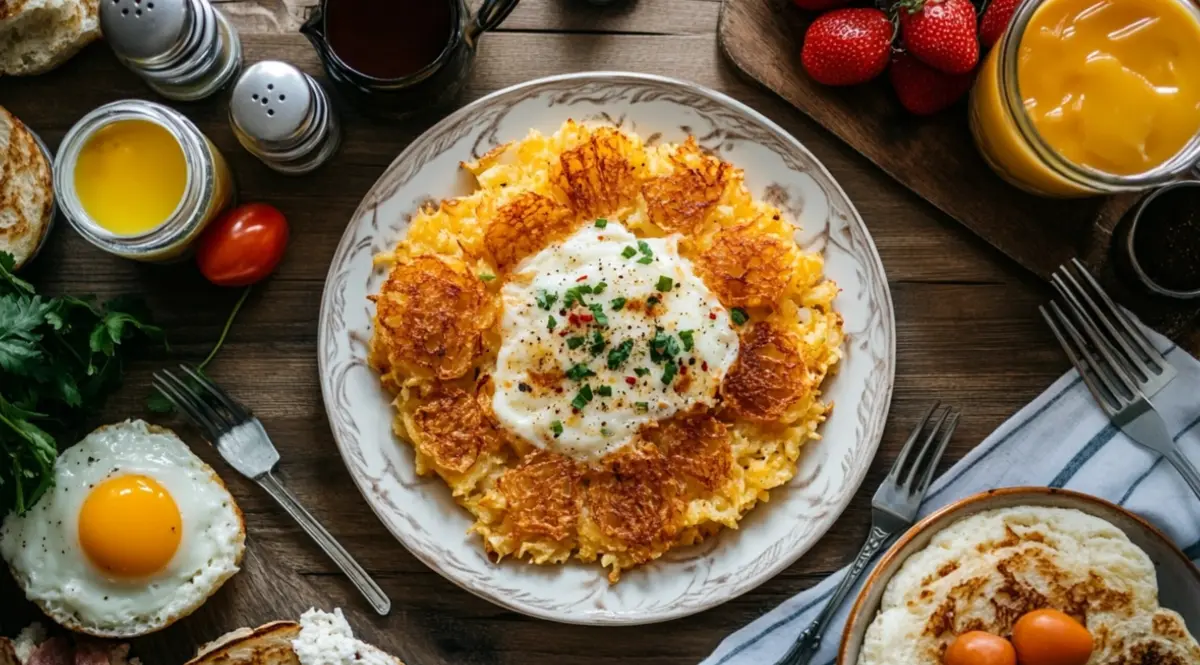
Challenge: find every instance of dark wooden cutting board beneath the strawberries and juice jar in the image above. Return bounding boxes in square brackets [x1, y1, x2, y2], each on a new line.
[718, 0, 1200, 339]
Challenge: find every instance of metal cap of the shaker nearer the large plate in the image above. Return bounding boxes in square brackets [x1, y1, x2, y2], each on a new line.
[229, 60, 313, 144]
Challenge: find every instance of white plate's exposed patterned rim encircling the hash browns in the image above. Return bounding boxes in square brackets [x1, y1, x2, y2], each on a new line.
[319, 72, 895, 624]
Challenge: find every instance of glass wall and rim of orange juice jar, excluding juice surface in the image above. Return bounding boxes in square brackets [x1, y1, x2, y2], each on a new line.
[970, 0, 1200, 198]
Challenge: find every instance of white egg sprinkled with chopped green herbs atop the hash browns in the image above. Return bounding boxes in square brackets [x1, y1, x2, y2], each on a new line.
[492, 220, 738, 461]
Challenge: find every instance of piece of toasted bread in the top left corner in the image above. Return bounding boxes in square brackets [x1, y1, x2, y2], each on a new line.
[0, 0, 100, 76]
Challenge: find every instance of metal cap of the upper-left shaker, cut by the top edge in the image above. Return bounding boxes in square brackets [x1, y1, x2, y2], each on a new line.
[100, 0, 192, 61]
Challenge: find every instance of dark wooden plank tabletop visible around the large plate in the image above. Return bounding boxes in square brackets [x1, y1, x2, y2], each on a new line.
[0, 0, 1099, 665]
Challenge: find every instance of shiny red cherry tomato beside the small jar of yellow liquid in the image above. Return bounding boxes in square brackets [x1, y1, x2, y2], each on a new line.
[196, 203, 288, 287]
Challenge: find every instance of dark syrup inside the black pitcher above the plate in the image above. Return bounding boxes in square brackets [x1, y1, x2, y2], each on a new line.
[325, 0, 455, 79]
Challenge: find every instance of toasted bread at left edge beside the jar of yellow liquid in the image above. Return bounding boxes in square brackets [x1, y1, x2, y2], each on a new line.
[0, 106, 54, 268]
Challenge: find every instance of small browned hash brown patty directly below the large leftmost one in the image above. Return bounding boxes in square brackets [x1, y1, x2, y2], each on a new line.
[409, 387, 504, 473]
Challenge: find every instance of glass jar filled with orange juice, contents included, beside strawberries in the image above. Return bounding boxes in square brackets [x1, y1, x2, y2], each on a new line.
[971, 0, 1200, 197]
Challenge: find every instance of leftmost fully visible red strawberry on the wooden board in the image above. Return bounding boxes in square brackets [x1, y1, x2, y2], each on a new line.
[800, 8, 895, 85]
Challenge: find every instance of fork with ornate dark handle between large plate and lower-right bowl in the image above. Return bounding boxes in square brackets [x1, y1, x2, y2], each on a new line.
[775, 402, 960, 665]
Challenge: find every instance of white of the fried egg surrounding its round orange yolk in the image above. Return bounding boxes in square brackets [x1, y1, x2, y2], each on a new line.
[0, 420, 245, 637]
